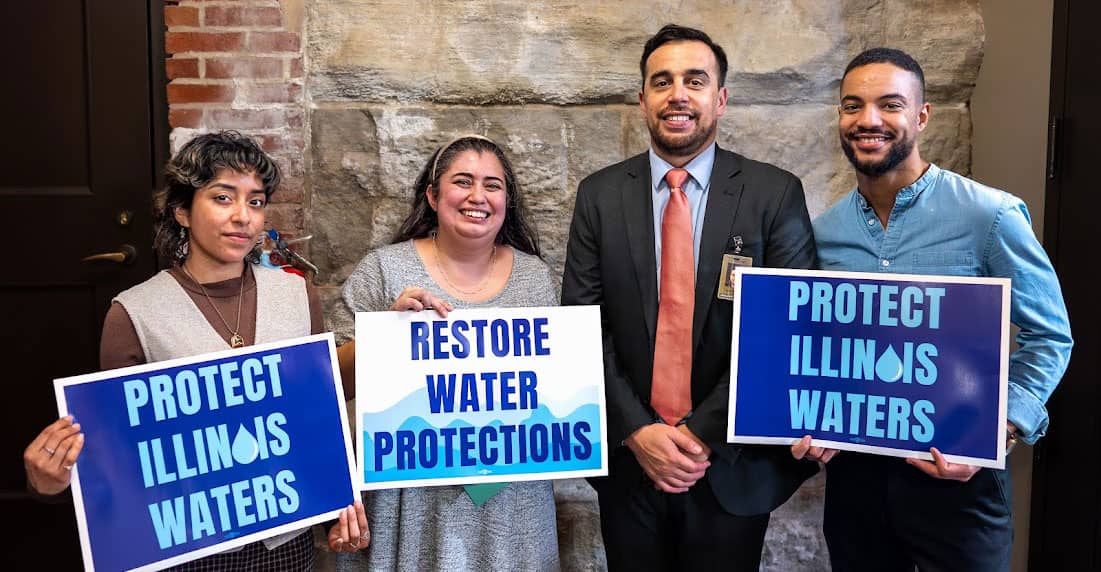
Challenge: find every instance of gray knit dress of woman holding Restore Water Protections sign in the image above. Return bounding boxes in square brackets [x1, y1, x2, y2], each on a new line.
[333, 241, 559, 572]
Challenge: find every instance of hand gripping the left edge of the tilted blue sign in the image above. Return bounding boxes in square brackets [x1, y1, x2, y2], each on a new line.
[23, 415, 84, 495]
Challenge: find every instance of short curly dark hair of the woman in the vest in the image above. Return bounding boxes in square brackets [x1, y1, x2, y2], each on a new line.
[153, 131, 281, 265]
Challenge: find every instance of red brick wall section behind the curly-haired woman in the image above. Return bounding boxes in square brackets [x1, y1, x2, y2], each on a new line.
[164, 0, 307, 235]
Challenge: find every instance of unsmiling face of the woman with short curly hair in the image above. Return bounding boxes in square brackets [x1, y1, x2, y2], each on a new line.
[175, 169, 268, 282]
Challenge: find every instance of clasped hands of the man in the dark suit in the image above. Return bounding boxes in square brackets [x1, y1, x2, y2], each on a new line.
[624, 424, 711, 493]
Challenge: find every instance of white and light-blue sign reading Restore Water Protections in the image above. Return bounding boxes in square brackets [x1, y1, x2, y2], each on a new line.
[356, 306, 608, 490]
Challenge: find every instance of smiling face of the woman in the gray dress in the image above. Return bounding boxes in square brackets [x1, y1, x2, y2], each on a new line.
[428, 150, 508, 242]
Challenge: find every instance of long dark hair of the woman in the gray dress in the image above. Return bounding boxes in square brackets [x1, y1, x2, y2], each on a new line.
[394, 135, 543, 257]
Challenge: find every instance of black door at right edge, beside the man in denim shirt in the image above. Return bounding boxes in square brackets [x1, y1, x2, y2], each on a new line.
[1028, 0, 1101, 571]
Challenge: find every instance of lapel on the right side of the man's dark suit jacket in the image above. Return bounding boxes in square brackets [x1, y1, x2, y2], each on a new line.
[691, 149, 742, 351]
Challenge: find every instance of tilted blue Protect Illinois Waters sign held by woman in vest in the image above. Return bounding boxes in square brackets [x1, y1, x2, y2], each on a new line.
[54, 333, 358, 571]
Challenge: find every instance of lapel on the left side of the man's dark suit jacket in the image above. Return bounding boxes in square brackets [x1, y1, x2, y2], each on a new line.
[620, 153, 657, 338]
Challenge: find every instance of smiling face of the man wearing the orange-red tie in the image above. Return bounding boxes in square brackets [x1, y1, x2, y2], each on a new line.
[639, 40, 727, 166]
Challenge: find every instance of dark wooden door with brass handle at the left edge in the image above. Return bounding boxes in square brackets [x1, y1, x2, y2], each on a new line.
[0, 0, 165, 570]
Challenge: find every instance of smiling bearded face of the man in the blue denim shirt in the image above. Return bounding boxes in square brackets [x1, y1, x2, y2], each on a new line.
[838, 64, 929, 178]
